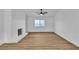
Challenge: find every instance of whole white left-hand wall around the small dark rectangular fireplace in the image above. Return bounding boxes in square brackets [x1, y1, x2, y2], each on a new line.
[0, 9, 28, 45]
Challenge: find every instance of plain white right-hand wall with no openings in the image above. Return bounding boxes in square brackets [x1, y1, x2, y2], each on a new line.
[55, 9, 79, 47]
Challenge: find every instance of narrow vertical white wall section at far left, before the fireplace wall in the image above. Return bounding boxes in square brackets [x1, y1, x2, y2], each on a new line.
[4, 9, 13, 42]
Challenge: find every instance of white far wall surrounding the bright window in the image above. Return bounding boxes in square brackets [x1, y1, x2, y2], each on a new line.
[28, 16, 54, 32]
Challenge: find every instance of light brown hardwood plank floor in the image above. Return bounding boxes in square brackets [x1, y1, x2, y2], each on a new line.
[0, 32, 79, 50]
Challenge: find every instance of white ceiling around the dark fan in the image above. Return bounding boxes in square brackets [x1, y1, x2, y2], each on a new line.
[25, 9, 58, 17]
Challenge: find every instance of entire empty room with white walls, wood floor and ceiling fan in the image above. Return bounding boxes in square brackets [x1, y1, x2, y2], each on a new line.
[0, 9, 79, 50]
